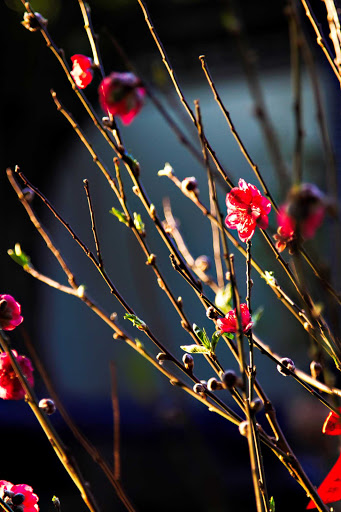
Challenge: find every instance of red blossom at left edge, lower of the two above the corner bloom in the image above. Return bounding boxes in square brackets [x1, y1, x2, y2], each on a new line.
[0, 350, 34, 400]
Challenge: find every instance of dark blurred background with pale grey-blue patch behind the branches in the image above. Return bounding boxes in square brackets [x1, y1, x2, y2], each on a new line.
[0, 0, 340, 512]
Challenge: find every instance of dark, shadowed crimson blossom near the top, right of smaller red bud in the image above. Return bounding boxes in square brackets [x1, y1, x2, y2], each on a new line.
[98, 72, 146, 124]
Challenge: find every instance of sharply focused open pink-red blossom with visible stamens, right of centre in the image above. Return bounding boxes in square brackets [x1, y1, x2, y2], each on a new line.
[225, 179, 271, 242]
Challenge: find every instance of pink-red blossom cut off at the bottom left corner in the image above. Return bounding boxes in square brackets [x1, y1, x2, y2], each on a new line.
[0, 480, 39, 512]
